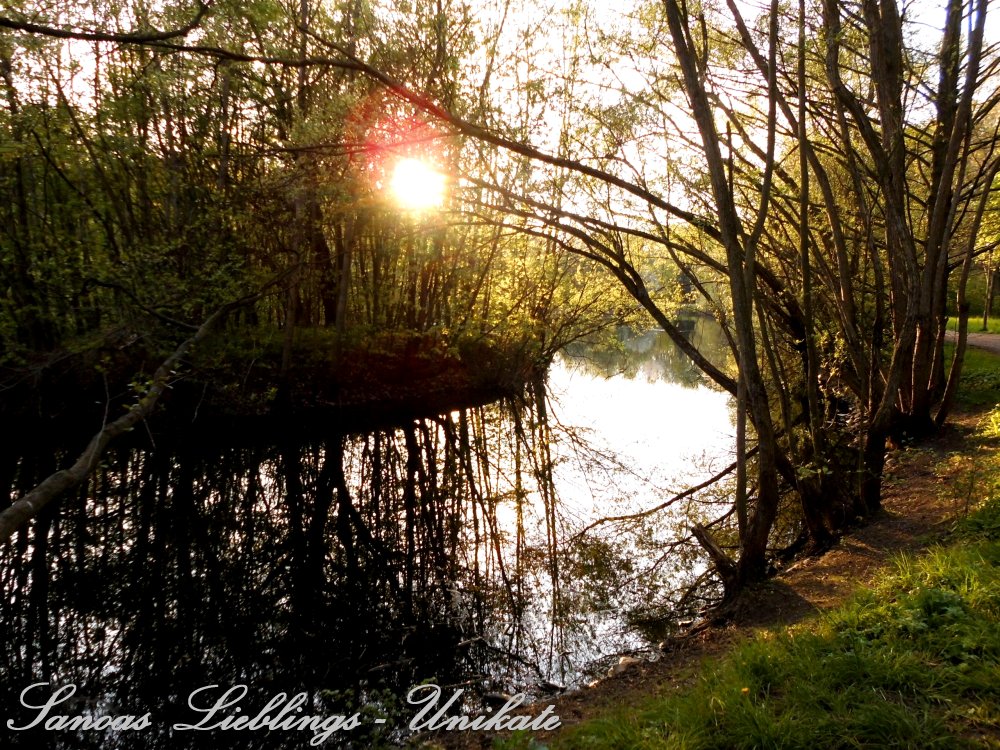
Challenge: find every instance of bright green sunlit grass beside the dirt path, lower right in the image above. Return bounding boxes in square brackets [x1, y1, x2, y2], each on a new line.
[498, 351, 1000, 750]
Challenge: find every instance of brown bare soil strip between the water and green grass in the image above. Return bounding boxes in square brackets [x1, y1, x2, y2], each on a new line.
[425, 334, 1000, 748]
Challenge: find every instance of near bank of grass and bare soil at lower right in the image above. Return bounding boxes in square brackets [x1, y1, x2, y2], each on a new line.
[434, 352, 1000, 750]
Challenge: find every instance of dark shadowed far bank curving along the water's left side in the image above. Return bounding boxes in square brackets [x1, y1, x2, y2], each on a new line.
[0, 329, 550, 446]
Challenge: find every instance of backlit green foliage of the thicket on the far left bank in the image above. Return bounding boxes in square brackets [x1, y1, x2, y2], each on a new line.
[0, 0, 629, 404]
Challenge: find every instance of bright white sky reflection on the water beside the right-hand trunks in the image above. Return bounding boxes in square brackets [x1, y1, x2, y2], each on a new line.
[549, 318, 734, 668]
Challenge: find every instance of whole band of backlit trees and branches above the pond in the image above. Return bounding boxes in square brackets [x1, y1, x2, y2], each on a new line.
[0, 0, 1000, 595]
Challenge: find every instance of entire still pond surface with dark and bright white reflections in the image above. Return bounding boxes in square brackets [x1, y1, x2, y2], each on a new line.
[0, 321, 733, 748]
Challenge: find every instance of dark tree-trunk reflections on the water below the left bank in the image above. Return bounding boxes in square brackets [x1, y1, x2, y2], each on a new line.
[0, 384, 558, 747]
